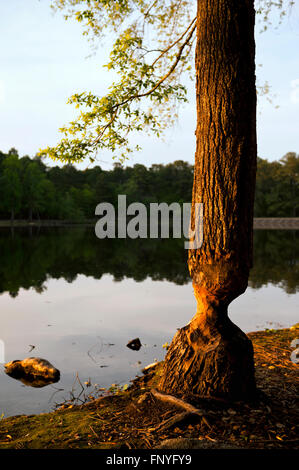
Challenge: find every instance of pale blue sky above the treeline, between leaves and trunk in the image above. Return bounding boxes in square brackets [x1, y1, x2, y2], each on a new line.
[0, 0, 299, 169]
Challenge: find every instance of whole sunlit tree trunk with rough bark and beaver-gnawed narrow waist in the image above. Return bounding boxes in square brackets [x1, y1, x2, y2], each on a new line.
[160, 0, 256, 400]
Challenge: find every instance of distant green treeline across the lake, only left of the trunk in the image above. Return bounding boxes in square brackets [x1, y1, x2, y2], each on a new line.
[0, 151, 193, 222]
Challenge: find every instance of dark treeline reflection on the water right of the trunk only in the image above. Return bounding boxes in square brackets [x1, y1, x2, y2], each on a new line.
[249, 230, 299, 294]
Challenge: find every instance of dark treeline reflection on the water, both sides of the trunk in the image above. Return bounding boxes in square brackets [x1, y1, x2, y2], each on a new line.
[0, 227, 299, 297]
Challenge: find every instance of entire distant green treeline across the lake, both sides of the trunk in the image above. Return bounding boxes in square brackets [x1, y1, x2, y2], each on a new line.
[0, 149, 299, 221]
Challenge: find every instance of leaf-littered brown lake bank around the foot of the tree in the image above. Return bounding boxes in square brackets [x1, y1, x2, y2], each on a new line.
[0, 324, 299, 449]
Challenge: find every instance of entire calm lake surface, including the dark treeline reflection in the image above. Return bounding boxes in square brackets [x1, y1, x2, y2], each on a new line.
[0, 227, 299, 416]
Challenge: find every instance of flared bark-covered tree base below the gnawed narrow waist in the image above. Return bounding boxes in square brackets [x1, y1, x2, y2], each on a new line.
[159, 317, 257, 401]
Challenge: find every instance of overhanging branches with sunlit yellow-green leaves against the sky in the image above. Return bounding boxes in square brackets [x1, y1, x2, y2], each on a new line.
[40, 0, 294, 162]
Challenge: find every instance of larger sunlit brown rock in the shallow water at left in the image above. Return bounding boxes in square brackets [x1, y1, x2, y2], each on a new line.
[4, 357, 60, 388]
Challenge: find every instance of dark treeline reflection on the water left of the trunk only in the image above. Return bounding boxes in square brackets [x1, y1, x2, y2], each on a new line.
[0, 227, 189, 297]
